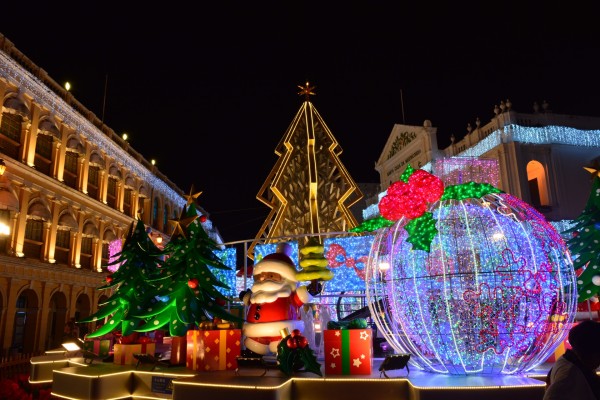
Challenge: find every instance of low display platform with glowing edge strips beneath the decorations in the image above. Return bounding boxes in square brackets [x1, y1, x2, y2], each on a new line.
[31, 355, 551, 400]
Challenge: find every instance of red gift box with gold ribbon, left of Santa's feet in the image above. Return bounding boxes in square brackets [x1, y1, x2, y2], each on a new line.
[186, 329, 242, 371]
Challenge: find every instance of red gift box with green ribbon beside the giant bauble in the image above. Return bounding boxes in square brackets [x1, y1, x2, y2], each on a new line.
[323, 329, 373, 375]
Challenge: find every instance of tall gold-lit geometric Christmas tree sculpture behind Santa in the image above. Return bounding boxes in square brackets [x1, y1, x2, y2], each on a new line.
[248, 82, 362, 254]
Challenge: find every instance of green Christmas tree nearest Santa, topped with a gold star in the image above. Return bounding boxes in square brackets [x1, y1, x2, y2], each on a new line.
[136, 192, 242, 336]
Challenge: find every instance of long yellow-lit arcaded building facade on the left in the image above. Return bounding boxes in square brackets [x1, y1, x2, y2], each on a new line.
[0, 35, 216, 353]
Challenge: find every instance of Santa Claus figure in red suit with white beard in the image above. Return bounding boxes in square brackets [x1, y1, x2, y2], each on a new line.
[240, 243, 312, 355]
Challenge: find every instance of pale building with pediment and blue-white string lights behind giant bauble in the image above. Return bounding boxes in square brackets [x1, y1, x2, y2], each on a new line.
[363, 100, 600, 224]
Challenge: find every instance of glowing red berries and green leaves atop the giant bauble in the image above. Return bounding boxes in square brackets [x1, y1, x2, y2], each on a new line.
[350, 164, 502, 252]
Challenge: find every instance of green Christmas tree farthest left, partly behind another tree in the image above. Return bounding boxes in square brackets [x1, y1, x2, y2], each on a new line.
[77, 220, 163, 338]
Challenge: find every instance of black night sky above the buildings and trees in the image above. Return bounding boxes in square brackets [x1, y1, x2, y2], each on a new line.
[0, 0, 600, 241]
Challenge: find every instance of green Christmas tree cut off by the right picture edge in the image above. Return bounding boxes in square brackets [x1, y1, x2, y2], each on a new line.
[565, 166, 600, 303]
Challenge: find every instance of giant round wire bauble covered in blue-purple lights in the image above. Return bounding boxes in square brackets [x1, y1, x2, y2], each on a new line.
[366, 193, 577, 374]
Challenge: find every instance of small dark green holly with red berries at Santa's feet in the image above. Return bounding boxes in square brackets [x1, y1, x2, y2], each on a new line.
[277, 329, 323, 376]
